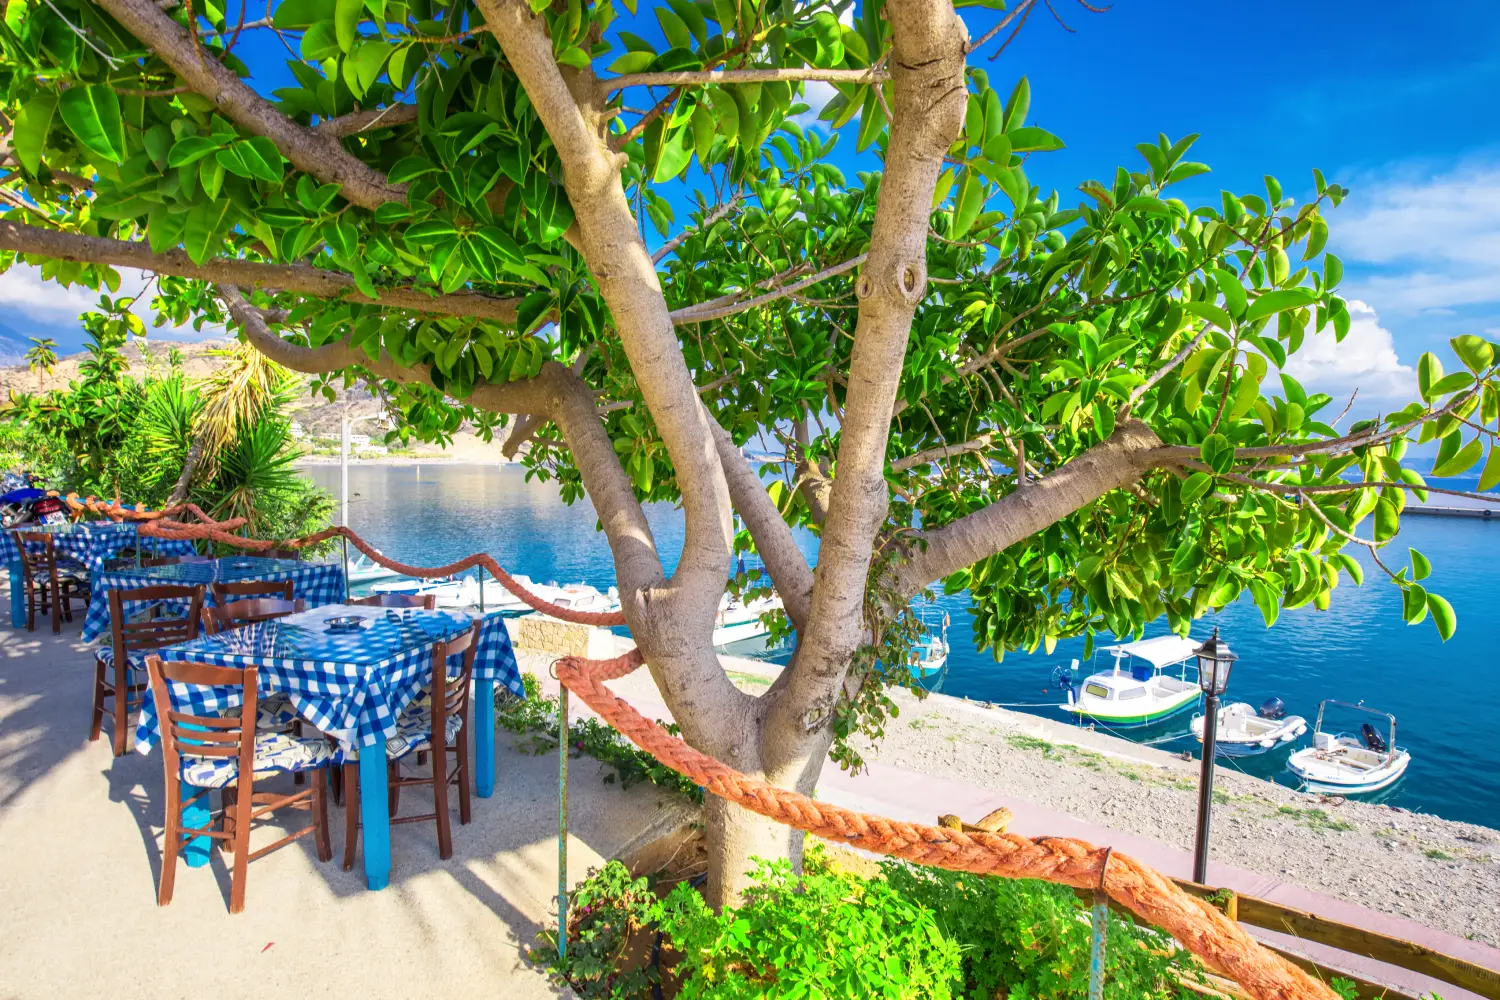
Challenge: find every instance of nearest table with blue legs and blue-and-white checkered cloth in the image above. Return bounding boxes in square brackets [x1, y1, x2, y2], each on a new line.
[135, 604, 525, 889]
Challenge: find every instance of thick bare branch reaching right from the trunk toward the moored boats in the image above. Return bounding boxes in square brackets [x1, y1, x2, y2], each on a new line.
[894, 420, 1160, 600]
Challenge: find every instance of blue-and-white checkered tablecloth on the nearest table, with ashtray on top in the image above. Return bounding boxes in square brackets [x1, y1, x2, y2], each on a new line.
[135, 606, 525, 754]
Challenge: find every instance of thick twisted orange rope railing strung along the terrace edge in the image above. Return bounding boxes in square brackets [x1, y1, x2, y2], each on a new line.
[68, 495, 1338, 1000]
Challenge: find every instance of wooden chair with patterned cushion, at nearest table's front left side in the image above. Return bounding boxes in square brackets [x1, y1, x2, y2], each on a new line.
[146, 657, 333, 913]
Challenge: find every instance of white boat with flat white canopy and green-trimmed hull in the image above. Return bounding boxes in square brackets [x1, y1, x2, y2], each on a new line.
[1058, 634, 1202, 727]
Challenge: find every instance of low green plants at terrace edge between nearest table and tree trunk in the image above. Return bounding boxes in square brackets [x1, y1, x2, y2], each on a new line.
[495, 673, 704, 804]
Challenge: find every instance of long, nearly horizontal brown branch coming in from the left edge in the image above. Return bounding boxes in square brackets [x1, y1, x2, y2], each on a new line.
[0, 219, 521, 325]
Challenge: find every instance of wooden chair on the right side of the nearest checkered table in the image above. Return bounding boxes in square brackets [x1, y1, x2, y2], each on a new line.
[342, 622, 482, 871]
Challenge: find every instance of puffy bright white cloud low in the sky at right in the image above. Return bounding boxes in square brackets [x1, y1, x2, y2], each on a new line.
[1284, 298, 1416, 400]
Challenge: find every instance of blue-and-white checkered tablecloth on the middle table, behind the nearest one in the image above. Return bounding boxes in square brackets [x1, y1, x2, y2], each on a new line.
[81, 556, 344, 642]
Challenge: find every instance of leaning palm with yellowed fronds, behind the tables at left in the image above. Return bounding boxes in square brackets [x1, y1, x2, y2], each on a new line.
[167, 342, 296, 505]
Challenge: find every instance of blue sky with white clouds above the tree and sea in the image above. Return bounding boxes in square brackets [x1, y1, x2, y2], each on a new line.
[0, 0, 1500, 412]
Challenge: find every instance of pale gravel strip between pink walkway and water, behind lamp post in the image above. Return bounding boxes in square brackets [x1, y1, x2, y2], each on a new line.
[866, 693, 1500, 946]
